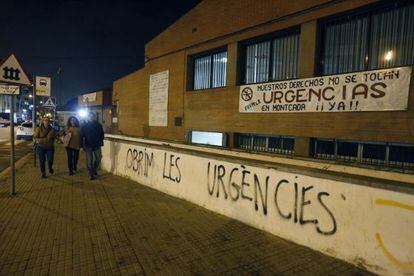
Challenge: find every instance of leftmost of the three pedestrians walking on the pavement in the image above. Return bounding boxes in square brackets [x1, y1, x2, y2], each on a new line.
[33, 117, 55, 178]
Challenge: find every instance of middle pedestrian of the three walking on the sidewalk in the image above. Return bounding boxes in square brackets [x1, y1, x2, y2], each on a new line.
[63, 116, 80, 175]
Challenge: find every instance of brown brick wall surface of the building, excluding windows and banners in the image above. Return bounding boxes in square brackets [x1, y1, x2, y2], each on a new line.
[114, 0, 414, 147]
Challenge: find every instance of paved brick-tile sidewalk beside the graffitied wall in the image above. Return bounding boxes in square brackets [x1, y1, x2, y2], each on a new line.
[0, 147, 368, 275]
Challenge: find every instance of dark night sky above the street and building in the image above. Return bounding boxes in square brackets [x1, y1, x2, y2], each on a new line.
[0, 0, 201, 104]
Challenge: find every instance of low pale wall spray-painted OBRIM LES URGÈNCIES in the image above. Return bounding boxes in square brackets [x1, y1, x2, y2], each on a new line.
[102, 136, 414, 275]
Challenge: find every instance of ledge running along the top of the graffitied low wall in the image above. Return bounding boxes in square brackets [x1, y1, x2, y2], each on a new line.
[105, 134, 414, 194]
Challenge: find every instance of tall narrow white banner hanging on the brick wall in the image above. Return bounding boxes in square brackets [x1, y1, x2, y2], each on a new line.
[149, 70, 169, 126]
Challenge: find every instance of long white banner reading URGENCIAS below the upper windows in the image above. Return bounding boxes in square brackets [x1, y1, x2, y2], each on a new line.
[239, 67, 412, 113]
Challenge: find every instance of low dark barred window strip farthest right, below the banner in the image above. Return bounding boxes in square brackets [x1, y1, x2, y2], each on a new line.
[313, 138, 414, 168]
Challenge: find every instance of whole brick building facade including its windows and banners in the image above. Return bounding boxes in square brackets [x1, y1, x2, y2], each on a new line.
[113, 0, 414, 170]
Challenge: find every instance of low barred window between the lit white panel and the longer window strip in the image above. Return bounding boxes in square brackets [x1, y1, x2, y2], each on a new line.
[236, 133, 295, 154]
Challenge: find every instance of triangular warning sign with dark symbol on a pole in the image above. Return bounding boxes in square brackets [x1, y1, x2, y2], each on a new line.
[0, 54, 31, 85]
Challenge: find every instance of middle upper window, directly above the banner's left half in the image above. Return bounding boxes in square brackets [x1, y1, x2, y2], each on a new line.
[244, 31, 299, 84]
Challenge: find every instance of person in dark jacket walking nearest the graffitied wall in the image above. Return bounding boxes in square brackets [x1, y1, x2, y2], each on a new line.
[79, 112, 104, 180]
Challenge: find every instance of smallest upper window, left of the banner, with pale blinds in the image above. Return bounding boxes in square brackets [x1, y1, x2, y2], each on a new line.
[193, 51, 227, 90]
